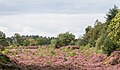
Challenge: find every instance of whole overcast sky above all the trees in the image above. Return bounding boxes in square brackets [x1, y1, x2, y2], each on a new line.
[0, 0, 120, 37]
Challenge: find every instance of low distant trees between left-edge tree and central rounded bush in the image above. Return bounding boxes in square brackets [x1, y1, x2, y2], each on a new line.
[7, 33, 54, 46]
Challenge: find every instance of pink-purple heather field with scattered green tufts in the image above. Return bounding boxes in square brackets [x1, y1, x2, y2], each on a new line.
[0, 46, 120, 70]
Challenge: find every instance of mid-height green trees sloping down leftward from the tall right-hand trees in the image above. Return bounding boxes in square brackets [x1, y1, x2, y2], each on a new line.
[77, 21, 103, 46]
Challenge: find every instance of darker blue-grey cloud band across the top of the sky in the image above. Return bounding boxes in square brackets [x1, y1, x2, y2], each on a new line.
[0, 0, 120, 14]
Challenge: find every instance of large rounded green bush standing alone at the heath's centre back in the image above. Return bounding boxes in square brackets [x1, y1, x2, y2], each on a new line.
[51, 32, 75, 48]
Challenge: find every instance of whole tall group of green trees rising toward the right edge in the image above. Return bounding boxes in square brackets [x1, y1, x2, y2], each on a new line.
[76, 5, 120, 55]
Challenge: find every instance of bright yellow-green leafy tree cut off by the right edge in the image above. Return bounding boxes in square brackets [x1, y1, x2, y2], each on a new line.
[107, 11, 120, 48]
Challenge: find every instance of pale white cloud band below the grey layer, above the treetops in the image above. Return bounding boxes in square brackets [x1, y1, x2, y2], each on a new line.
[0, 13, 104, 36]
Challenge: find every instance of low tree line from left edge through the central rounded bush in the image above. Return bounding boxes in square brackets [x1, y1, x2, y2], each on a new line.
[0, 31, 75, 48]
